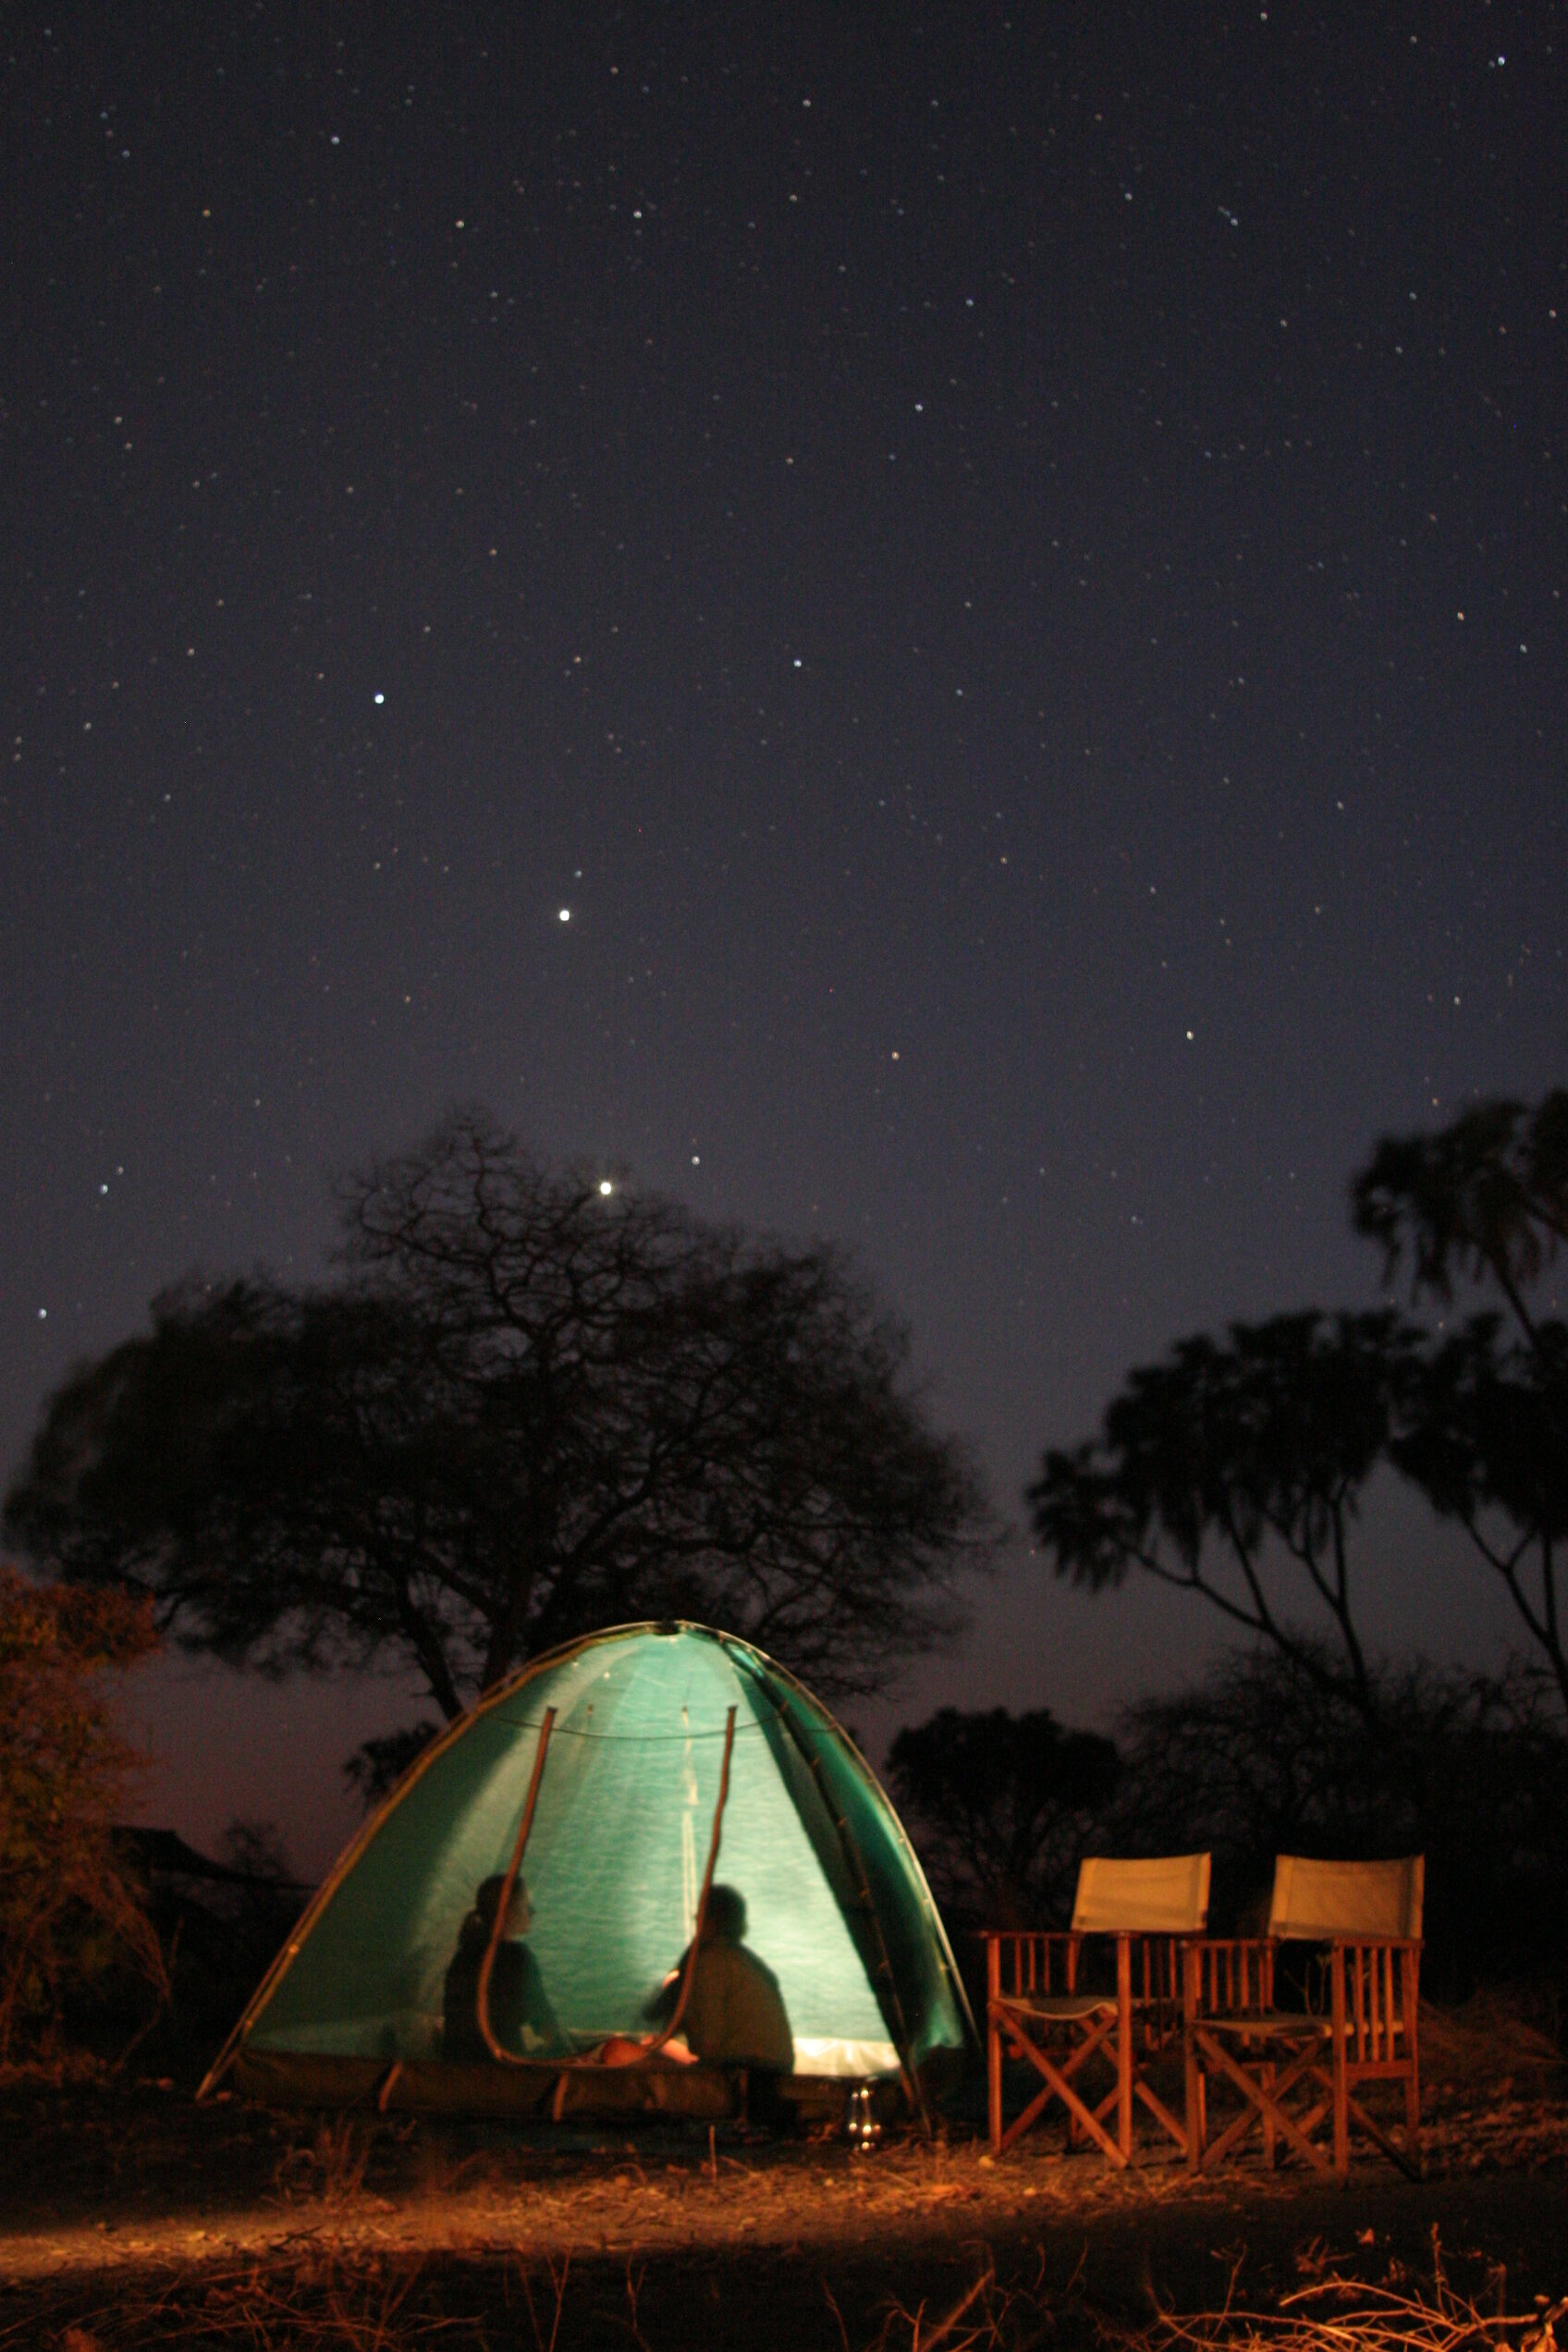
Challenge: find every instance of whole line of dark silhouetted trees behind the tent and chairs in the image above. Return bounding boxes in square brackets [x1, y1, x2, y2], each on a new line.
[0, 1089, 1568, 2041]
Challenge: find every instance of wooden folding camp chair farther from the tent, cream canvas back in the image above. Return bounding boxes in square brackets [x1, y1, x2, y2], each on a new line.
[1182, 1854, 1425, 2180]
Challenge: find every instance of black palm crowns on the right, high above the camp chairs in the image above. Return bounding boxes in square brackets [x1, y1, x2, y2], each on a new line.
[1030, 1089, 1568, 1724]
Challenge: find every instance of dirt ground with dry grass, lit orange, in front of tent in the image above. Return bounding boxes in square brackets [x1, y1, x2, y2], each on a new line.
[0, 2067, 1568, 2352]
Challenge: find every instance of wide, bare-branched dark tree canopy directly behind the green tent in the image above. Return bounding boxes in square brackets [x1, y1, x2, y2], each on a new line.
[5, 1115, 992, 1717]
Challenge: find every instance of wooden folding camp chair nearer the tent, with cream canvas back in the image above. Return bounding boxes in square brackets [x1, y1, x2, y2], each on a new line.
[985, 1854, 1208, 2166]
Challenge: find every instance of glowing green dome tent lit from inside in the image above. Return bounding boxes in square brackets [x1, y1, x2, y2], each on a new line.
[202, 1623, 978, 2114]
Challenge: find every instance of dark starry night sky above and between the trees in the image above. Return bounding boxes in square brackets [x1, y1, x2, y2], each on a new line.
[0, 0, 1568, 1869]
